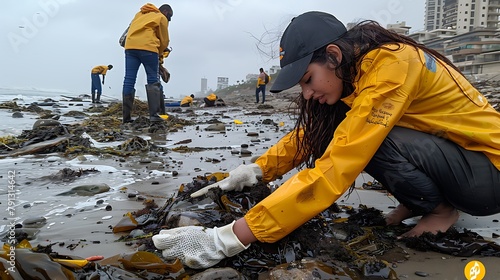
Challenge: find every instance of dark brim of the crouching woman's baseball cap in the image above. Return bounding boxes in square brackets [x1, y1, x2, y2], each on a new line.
[270, 53, 313, 93]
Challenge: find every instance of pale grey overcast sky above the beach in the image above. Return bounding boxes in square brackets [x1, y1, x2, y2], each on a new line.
[0, 0, 425, 98]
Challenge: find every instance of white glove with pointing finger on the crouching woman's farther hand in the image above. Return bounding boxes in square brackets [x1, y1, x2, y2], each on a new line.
[191, 163, 262, 197]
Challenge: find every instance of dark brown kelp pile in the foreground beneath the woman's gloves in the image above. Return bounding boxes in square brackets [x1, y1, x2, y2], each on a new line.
[0, 173, 500, 279]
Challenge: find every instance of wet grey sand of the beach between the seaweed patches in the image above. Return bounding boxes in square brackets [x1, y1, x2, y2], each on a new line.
[0, 90, 500, 279]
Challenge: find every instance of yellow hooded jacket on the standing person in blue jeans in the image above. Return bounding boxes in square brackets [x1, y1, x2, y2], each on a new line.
[125, 3, 170, 55]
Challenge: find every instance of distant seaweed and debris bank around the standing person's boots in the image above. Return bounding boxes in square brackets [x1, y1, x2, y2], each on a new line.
[0, 101, 194, 157]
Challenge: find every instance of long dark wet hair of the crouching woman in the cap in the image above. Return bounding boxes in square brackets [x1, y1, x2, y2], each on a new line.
[294, 20, 460, 168]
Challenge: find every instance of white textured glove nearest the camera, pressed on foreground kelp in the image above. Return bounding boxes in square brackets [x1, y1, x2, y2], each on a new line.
[152, 221, 250, 269]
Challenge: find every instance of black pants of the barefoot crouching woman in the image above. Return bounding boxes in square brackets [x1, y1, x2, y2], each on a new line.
[365, 127, 500, 216]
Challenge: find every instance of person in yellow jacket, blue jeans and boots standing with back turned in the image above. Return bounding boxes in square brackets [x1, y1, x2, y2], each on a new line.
[122, 3, 174, 123]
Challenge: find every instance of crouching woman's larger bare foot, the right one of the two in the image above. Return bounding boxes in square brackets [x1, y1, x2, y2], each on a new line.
[400, 203, 460, 237]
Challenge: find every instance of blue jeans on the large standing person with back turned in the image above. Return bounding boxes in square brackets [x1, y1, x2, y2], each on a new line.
[122, 50, 160, 95]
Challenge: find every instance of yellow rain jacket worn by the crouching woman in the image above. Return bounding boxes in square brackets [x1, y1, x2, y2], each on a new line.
[245, 45, 500, 242]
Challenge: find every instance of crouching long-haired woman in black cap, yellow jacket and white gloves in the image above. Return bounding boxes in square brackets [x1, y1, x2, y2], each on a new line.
[153, 12, 500, 267]
